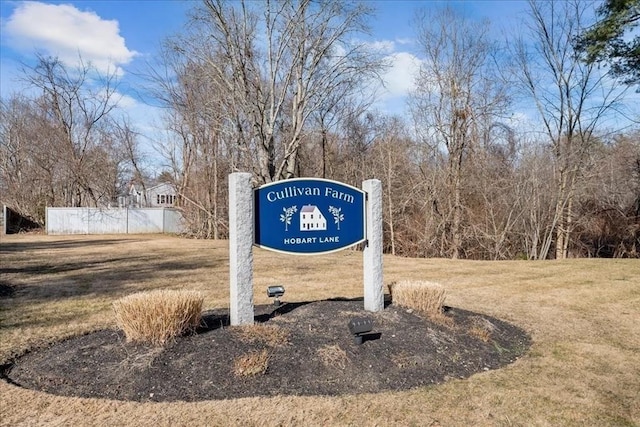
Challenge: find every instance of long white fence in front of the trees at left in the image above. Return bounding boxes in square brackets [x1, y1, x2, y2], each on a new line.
[46, 208, 184, 234]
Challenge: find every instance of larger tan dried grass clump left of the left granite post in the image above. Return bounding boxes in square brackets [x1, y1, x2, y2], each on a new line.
[113, 290, 204, 345]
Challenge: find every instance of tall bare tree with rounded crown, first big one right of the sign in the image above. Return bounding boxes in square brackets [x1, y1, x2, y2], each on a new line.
[412, 9, 507, 258]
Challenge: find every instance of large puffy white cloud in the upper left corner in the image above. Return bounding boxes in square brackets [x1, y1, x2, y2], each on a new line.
[3, 2, 137, 74]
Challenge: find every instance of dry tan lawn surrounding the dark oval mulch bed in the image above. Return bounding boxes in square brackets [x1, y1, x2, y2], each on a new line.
[0, 235, 640, 427]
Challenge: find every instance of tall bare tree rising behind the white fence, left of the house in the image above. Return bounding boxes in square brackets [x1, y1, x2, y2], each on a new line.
[24, 56, 124, 206]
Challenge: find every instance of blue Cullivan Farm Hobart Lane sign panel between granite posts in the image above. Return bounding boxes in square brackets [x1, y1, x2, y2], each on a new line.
[254, 178, 365, 254]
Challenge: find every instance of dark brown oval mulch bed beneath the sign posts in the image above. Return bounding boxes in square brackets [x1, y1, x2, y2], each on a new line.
[2, 300, 531, 402]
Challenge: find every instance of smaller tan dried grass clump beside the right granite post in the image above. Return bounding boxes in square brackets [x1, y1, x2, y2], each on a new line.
[389, 280, 446, 318]
